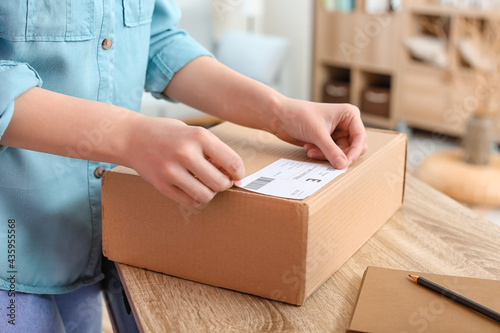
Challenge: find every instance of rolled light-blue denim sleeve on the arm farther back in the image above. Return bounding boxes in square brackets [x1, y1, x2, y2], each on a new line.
[145, 0, 213, 99]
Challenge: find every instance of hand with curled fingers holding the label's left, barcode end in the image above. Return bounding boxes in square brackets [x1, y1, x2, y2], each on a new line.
[127, 117, 245, 207]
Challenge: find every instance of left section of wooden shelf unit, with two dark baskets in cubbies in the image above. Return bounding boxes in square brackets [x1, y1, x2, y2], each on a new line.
[313, 1, 400, 128]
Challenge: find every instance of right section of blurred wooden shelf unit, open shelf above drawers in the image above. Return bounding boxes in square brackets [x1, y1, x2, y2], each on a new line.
[399, 3, 500, 138]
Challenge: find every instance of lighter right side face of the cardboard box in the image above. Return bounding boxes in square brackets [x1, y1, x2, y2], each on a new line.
[306, 130, 406, 296]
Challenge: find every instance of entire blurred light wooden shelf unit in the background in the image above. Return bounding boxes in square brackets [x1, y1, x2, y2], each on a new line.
[312, 0, 500, 138]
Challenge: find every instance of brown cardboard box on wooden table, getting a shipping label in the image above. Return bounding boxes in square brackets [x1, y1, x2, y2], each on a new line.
[102, 123, 406, 305]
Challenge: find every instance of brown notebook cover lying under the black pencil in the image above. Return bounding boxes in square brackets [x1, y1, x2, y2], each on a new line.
[347, 267, 500, 333]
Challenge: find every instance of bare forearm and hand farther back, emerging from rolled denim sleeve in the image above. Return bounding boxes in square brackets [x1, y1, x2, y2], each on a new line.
[164, 57, 366, 169]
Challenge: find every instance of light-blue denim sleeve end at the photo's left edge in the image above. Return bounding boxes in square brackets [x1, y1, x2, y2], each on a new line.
[0, 60, 42, 152]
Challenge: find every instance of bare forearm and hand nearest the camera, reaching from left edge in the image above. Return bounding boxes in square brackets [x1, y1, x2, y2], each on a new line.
[0, 88, 245, 207]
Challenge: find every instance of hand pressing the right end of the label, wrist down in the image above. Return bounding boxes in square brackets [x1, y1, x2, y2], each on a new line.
[271, 98, 367, 169]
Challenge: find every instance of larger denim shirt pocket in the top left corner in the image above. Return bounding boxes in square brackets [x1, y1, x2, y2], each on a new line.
[0, 0, 95, 42]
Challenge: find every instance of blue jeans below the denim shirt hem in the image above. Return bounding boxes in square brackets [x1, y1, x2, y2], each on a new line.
[0, 283, 102, 333]
